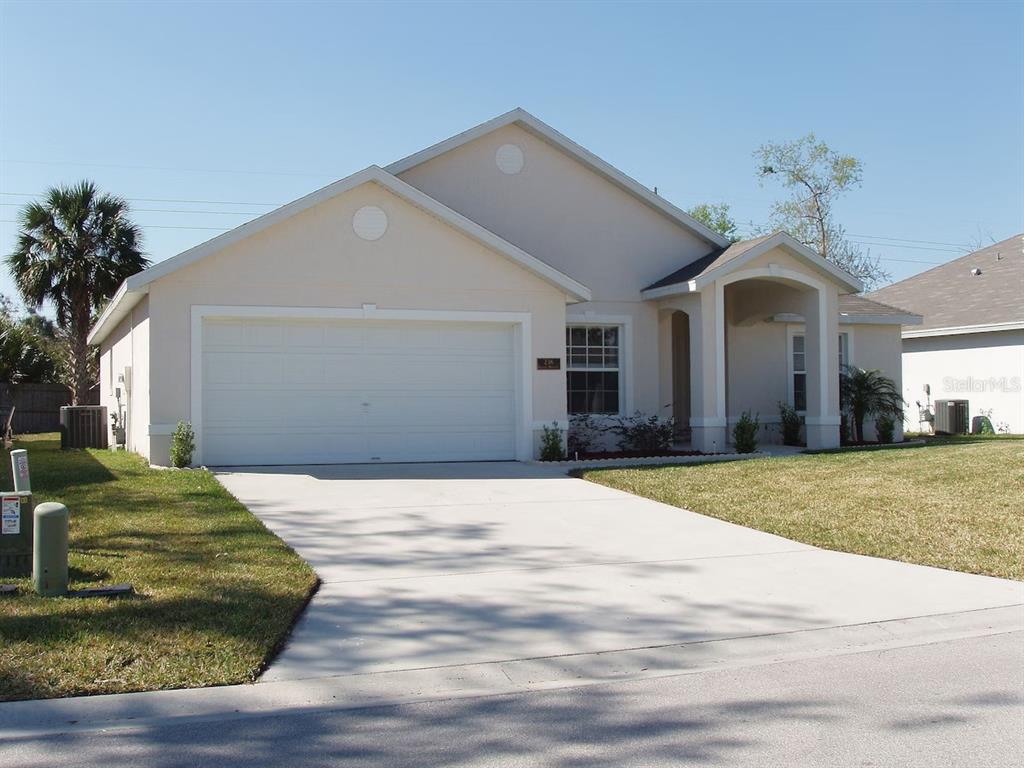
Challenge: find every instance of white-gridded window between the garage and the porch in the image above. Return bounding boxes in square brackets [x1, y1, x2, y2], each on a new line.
[565, 326, 623, 415]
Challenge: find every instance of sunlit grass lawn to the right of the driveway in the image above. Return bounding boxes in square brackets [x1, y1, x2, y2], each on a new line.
[581, 438, 1024, 580]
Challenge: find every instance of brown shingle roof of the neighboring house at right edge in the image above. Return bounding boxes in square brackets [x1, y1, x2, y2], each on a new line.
[868, 233, 1024, 336]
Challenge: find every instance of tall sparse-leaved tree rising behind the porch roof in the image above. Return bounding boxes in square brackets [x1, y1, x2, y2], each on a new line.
[754, 133, 890, 288]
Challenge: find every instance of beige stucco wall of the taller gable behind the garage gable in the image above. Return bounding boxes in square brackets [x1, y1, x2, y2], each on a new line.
[400, 120, 713, 423]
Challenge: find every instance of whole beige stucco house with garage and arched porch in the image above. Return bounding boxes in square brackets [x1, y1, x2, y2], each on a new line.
[90, 110, 913, 465]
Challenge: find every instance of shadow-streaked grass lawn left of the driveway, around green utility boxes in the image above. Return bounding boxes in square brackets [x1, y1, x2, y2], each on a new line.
[0, 435, 316, 700]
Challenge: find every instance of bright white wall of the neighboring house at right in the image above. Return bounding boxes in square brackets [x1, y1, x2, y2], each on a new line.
[903, 331, 1024, 434]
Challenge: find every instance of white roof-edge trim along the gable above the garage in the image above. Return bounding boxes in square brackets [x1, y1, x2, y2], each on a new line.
[89, 165, 591, 344]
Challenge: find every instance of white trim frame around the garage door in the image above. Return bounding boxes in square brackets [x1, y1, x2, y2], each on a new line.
[189, 304, 534, 465]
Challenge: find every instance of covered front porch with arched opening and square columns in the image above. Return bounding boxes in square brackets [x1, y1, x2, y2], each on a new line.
[644, 233, 859, 453]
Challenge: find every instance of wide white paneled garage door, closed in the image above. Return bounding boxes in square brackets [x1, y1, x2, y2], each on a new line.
[201, 318, 516, 466]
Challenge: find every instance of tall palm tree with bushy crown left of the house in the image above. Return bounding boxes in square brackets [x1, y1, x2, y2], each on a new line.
[7, 181, 150, 404]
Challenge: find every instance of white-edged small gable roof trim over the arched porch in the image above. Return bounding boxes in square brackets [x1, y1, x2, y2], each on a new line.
[641, 231, 864, 299]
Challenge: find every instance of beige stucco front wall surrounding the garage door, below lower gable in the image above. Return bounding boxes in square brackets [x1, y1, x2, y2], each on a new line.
[139, 183, 566, 464]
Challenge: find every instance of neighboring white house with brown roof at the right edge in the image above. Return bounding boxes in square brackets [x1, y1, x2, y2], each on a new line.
[870, 234, 1024, 433]
